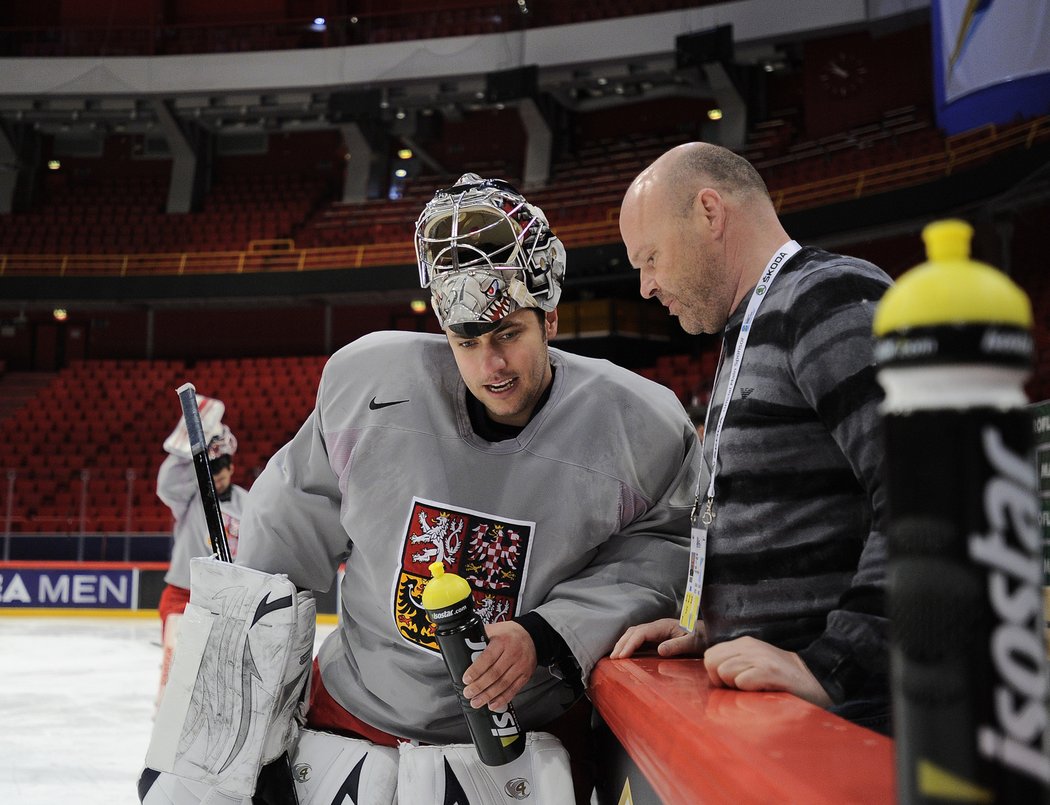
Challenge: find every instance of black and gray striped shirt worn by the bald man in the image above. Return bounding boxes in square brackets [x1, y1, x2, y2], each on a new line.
[699, 248, 890, 703]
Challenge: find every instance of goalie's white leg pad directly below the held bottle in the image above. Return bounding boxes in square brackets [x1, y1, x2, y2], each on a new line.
[398, 733, 575, 805]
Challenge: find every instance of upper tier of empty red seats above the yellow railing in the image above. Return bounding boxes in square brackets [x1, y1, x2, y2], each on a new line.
[0, 57, 1050, 276]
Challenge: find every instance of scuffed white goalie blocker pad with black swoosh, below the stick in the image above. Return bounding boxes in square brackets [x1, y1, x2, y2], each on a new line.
[146, 556, 316, 796]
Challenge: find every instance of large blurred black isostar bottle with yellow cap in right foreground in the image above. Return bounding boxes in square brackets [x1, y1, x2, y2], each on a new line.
[875, 220, 1050, 805]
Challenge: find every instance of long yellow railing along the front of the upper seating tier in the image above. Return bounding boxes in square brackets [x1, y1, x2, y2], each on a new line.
[0, 116, 1050, 277]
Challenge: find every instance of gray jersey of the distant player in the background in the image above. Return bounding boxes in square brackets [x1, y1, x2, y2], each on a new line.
[156, 456, 248, 590]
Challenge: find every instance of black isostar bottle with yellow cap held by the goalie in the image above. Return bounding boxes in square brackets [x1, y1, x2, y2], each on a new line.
[423, 562, 525, 766]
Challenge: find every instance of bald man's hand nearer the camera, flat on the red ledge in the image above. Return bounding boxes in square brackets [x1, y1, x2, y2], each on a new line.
[704, 637, 832, 707]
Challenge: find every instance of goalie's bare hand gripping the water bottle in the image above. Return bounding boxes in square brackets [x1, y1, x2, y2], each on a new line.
[463, 620, 537, 709]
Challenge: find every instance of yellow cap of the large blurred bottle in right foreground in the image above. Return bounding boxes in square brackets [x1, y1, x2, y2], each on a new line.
[874, 219, 1032, 336]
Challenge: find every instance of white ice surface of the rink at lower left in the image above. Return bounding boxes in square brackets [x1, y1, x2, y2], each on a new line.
[0, 615, 333, 805]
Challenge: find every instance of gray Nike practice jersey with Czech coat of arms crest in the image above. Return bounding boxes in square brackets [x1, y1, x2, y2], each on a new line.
[238, 333, 699, 743]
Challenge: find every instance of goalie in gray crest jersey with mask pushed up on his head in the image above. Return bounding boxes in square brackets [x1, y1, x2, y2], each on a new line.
[139, 174, 699, 803]
